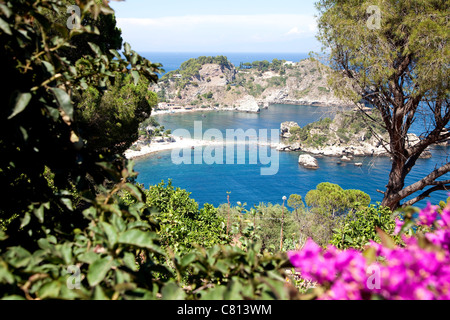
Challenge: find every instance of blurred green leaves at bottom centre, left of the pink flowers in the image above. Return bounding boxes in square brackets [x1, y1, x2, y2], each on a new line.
[174, 244, 299, 300]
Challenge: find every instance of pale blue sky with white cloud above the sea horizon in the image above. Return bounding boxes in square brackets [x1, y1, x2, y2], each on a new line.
[110, 0, 320, 53]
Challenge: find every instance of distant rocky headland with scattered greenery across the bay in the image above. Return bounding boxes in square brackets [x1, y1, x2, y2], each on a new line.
[152, 56, 352, 112]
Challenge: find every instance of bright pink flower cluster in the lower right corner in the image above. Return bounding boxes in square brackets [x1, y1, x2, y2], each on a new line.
[288, 203, 450, 300]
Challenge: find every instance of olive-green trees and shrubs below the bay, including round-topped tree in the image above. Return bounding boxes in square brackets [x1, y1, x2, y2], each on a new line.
[214, 182, 376, 253]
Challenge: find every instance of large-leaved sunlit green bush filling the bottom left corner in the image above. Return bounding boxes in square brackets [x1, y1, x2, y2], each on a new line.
[0, 163, 169, 300]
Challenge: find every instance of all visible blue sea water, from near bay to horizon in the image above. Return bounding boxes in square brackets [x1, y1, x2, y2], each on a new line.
[135, 53, 450, 208]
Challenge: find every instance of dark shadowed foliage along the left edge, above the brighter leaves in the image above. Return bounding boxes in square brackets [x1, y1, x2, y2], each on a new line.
[0, 1, 159, 246]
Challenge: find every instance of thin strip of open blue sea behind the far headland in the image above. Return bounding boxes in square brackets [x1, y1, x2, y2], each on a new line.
[139, 52, 308, 75]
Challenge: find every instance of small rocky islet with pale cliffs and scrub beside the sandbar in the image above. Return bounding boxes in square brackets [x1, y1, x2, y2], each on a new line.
[277, 110, 431, 168]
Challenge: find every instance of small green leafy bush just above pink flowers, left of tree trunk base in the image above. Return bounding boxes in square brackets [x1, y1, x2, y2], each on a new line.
[330, 205, 402, 249]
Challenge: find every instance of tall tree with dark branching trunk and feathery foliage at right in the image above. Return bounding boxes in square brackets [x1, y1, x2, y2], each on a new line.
[317, 0, 450, 209]
